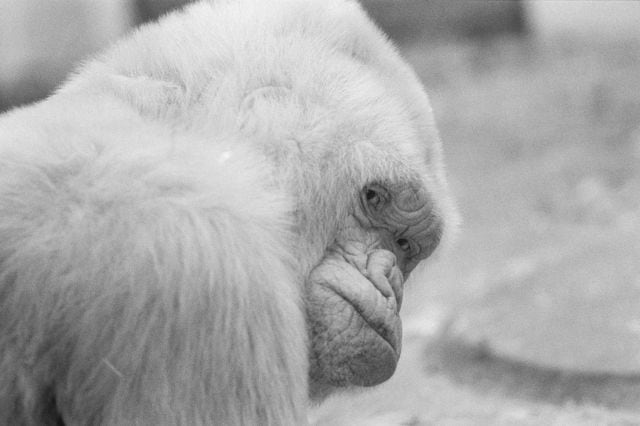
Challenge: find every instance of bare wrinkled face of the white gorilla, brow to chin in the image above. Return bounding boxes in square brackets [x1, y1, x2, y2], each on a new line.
[307, 182, 442, 398]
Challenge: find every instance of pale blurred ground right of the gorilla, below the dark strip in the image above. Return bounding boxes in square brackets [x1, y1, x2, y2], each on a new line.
[313, 34, 640, 426]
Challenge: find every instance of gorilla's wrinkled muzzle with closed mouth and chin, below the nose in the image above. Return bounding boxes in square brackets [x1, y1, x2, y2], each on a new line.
[307, 256, 402, 387]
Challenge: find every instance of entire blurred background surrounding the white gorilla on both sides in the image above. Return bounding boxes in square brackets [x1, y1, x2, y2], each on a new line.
[0, 0, 640, 425]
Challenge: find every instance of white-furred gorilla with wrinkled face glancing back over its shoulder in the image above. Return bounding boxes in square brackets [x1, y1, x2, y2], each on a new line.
[0, 0, 454, 425]
